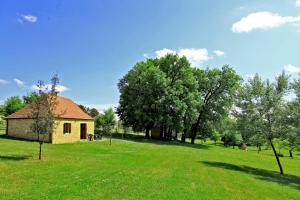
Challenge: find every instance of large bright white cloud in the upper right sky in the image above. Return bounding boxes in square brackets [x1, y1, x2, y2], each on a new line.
[231, 12, 300, 33]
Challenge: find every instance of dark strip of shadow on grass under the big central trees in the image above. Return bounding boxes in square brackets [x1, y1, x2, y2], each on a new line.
[104, 133, 211, 149]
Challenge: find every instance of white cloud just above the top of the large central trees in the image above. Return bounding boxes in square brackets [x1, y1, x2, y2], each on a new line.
[155, 48, 210, 65]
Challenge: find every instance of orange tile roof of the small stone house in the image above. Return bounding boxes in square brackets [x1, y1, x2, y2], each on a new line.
[6, 96, 94, 120]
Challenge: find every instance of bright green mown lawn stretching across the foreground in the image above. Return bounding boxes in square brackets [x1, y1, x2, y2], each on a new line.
[0, 136, 300, 200]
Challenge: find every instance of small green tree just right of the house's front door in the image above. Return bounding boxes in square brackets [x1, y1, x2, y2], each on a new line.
[96, 108, 117, 145]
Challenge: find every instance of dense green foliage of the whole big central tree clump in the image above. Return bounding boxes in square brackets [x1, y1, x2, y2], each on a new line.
[117, 54, 240, 141]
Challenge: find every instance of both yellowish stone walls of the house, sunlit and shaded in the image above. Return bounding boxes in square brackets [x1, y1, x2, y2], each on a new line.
[7, 119, 94, 144]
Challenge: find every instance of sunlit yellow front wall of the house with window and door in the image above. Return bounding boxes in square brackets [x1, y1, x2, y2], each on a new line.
[52, 119, 94, 144]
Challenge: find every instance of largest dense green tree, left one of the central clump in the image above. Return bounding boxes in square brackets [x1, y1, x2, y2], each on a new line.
[117, 54, 199, 140]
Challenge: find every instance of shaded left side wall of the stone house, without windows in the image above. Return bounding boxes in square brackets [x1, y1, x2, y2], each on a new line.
[7, 119, 49, 142]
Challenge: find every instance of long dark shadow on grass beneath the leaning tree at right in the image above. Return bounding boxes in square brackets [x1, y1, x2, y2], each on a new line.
[201, 161, 300, 190]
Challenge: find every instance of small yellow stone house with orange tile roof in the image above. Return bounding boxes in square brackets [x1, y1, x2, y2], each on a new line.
[5, 96, 94, 144]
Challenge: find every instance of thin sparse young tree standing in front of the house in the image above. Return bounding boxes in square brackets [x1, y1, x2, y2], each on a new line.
[29, 75, 59, 160]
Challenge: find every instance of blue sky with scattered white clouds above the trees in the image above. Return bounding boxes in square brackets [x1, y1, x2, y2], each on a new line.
[0, 0, 300, 110]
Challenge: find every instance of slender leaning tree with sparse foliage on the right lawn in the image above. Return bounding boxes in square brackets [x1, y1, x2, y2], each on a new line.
[236, 73, 289, 174]
